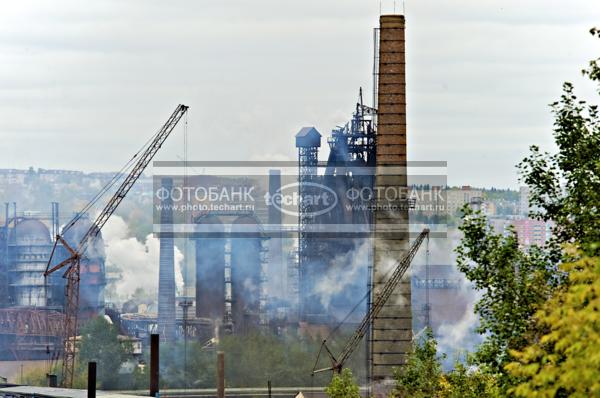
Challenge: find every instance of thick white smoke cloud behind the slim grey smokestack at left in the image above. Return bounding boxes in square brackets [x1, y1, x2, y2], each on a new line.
[102, 215, 184, 300]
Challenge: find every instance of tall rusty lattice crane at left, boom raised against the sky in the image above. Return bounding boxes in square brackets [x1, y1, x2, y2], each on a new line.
[44, 104, 188, 388]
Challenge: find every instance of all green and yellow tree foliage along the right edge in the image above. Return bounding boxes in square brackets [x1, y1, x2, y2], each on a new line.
[457, 29, 600, 397]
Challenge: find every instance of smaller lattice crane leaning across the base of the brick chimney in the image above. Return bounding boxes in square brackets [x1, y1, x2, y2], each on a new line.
[312, 228, 429, 375]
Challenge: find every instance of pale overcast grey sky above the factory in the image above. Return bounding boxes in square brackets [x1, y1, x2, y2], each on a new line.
[0, 0, 600, 188]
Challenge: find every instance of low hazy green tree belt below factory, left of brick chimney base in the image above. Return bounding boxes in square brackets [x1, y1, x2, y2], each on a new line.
[152, 330, 365, 388]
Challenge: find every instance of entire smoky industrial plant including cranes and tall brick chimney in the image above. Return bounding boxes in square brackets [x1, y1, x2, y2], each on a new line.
[0, 15, 459, 392]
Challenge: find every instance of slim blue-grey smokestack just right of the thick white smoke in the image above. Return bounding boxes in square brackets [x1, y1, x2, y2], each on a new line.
[158, 178, 176, 341]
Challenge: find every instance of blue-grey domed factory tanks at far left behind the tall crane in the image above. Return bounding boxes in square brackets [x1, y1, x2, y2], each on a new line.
[0, 203, 106, 360]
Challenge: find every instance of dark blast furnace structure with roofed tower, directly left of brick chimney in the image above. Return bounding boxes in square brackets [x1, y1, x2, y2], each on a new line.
[296, 93, 375, 325]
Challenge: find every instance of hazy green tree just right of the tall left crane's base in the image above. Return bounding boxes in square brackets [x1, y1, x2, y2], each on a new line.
[77, 317, 133, 389]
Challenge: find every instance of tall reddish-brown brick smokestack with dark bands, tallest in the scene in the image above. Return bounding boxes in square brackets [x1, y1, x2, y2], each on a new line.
[370, 15, 412, 380]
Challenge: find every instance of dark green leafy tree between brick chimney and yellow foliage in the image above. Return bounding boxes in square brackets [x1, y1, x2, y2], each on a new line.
[456, 206, 560, 389]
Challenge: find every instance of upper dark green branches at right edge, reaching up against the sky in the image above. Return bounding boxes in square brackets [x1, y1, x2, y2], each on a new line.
[517, 29, 600, 254]
